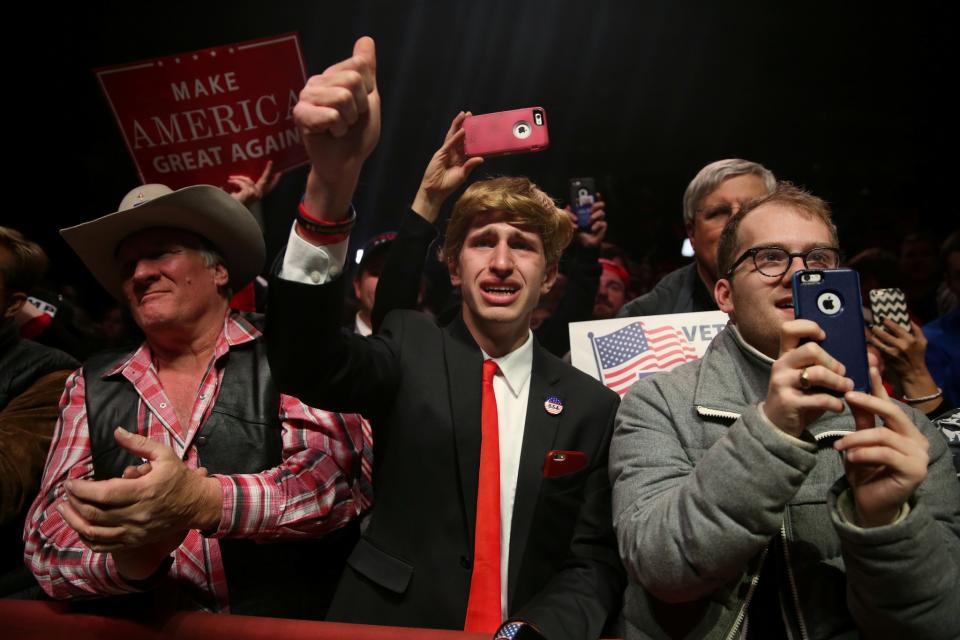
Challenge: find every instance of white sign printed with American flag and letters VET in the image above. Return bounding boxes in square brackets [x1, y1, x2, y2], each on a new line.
[570, 311, 727, 396]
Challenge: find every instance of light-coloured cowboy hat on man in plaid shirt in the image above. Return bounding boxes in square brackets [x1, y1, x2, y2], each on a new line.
[60, 184, 266, 299]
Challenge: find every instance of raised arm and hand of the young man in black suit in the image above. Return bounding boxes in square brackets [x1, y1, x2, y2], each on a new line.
[266, 37, 397, 417]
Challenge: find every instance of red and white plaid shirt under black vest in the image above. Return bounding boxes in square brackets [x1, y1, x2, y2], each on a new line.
[24, 313, 373, 611]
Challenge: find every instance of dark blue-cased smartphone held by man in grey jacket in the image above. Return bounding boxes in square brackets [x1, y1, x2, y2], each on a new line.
[793, 269, 870, 395]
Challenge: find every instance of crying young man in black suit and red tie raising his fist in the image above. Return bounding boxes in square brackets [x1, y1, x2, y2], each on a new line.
[267, 38, 626, 640]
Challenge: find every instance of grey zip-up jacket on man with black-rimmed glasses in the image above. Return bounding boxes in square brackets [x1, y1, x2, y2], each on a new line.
[610, 325, 960, 639]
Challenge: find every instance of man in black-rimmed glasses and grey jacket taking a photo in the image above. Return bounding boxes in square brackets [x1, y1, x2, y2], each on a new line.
[610, 184, 960, 639]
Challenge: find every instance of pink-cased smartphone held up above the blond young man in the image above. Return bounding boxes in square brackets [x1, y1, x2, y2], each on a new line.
[463, 107, 550, 158]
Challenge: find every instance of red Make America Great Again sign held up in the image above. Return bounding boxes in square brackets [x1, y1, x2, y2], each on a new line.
[95, 33, 307, 189]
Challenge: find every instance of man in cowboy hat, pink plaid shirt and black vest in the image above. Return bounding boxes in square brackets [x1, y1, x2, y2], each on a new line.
[25, 185, 370, 617]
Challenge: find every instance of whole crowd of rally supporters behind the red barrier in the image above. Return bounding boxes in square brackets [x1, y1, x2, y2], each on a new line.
[0, 38, 960, 640]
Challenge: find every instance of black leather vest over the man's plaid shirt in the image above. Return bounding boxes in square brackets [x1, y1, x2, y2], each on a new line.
[84, 316, 359, 620]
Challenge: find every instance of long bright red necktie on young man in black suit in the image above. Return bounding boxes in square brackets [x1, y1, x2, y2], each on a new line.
[463, 360, 501, 633]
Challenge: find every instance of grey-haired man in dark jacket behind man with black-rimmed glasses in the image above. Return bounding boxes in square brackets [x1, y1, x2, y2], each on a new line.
[617, 158, 777, 318]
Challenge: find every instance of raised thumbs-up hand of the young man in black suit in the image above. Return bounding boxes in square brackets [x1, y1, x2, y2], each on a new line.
[293, 36, 380, 221]
